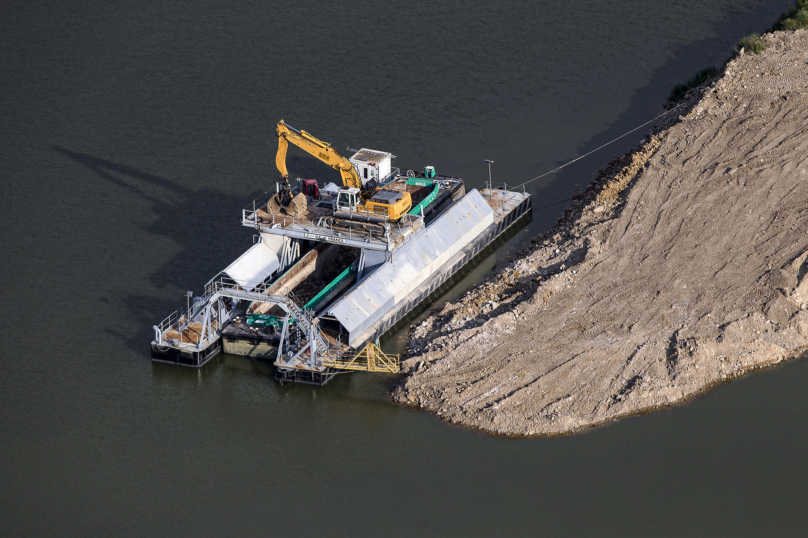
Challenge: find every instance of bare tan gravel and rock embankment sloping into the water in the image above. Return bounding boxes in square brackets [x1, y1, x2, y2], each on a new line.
[392, 30, 808, 435]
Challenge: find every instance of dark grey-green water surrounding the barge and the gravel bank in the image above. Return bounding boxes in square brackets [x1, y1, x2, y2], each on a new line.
[0, 0, 808, 536]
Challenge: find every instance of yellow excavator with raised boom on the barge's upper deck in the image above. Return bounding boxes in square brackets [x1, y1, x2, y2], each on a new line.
[275, 120, 412, 222]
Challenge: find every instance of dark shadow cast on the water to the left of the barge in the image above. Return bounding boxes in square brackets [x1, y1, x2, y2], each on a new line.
[52, 145, 348, 357]
